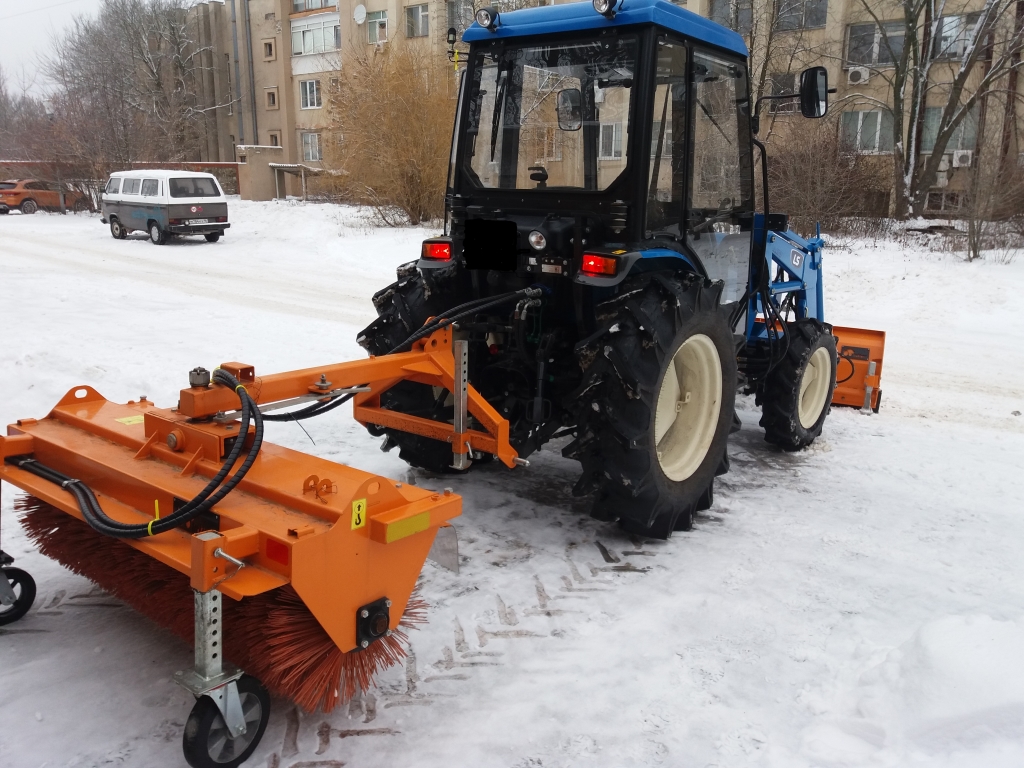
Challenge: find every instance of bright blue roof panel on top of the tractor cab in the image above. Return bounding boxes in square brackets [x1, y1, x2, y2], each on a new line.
[462, 0, 746, 57]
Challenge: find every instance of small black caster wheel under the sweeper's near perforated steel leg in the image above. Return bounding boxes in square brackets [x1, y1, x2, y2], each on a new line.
[181, 675, 270, 768]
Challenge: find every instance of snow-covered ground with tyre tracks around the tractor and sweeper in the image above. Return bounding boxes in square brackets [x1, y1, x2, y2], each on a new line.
[0, 202, 1024, 768]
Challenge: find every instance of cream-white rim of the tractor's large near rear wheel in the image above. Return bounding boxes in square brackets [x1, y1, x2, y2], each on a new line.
[654, 334, 722, 482]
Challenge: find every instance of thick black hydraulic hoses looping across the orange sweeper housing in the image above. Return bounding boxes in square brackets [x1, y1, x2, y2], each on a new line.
[8, 369, 263, 539]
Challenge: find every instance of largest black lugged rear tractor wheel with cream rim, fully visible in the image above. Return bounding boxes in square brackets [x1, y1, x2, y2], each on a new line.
[562, 272, 736, 539]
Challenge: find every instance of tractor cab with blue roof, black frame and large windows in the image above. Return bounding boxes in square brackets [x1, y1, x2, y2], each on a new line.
[420, 0, 823, 317]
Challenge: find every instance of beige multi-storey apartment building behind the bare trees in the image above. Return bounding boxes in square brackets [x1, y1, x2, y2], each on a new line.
[191, 0, 1024, 212]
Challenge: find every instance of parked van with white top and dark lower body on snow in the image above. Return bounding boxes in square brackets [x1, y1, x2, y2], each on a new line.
[101, 170, 230, 246]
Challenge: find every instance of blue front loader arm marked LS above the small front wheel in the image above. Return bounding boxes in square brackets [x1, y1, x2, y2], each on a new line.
[746, 214, 825, 343]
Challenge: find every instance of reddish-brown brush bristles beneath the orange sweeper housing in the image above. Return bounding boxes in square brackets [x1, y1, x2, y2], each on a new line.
[14, 497, 427, 712]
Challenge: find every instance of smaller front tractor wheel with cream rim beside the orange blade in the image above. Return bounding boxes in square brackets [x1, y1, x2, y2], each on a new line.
[760, 319, 837, 451]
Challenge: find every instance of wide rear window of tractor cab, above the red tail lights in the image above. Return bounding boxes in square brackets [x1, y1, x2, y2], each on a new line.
[462, 36, 638, 190]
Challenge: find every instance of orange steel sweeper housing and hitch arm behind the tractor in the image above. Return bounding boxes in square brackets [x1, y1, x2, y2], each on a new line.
[0, 329, 516, 650]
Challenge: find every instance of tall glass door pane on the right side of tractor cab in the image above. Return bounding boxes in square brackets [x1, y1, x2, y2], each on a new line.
[686, 50, 754, 302]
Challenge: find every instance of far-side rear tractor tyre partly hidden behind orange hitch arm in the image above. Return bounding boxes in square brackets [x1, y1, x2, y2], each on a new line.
[356, 262, 468, 473]
